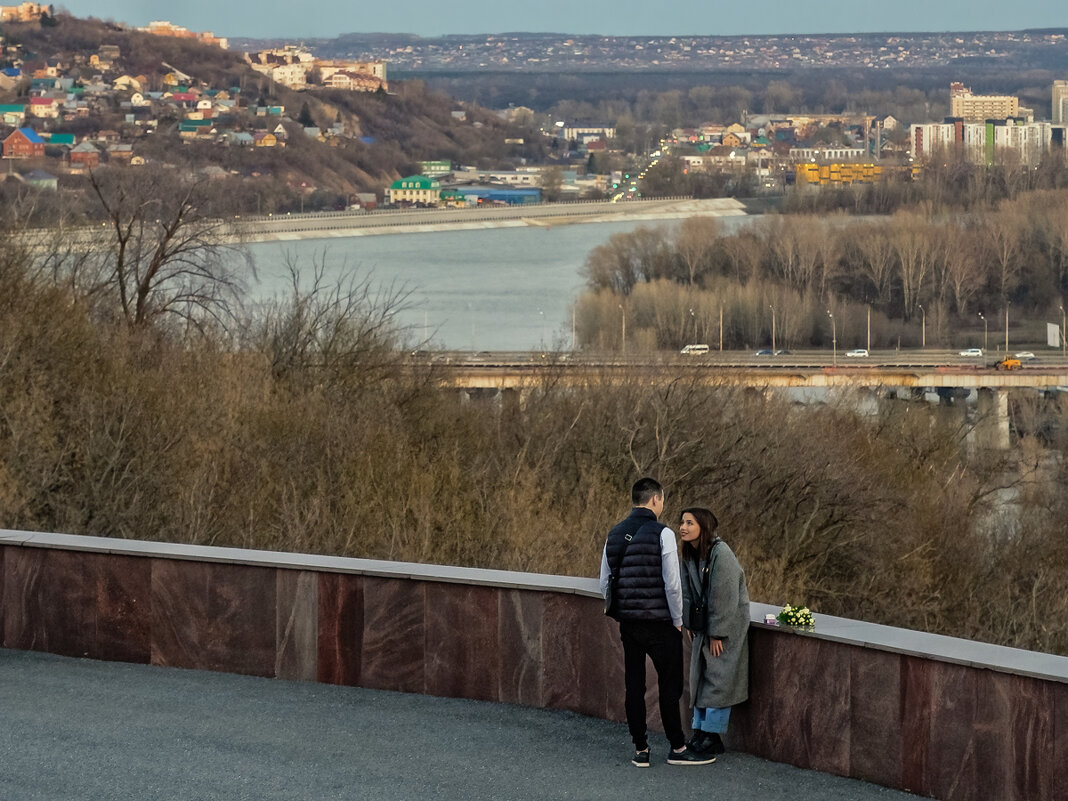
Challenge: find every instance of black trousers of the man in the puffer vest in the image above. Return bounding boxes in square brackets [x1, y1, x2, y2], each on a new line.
[619, 621, 686, 751]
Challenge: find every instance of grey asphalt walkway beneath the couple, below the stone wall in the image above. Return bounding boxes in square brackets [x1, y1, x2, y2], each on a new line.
[0, 649, 915, 801]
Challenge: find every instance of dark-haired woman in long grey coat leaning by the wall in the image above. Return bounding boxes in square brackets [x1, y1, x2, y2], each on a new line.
[678, 507, 749, 754]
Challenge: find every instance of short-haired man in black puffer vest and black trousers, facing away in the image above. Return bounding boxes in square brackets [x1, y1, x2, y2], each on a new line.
[600, 478, 716, 768]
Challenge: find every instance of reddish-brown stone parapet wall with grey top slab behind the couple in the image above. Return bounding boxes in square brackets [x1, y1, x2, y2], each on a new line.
[0, 531, 1068, 801]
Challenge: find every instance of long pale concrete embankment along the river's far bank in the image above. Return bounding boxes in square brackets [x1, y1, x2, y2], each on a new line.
[234, 198, 749, 241]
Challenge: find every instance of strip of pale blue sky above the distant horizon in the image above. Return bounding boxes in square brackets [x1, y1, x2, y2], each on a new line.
[56, 0, 1068, 38]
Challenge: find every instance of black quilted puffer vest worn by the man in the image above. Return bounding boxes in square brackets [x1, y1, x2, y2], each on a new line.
[604, 507, 671, 623]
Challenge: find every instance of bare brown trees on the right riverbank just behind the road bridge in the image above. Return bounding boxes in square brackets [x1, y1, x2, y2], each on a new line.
[576, 189, 1068, 349]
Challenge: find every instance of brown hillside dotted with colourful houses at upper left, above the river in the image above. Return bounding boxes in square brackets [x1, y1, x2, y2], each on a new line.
[0, 14, 543, 211]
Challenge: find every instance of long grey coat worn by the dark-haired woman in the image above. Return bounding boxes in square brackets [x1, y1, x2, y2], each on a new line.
[682, 539, 749, 708]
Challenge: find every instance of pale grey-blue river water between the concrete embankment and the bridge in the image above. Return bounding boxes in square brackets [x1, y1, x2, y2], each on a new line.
[248, 217, 752, 350]
